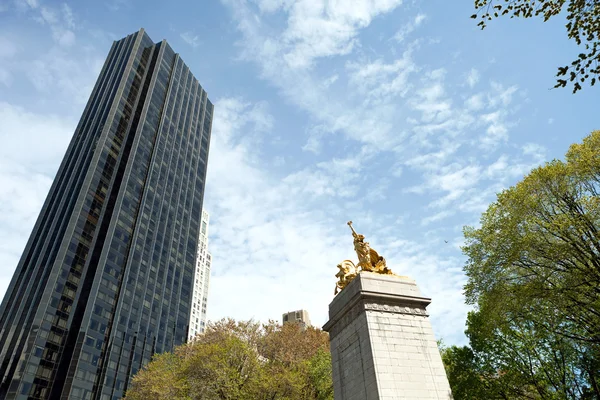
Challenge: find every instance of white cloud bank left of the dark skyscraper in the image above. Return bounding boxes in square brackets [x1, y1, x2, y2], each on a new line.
[0, 102, 75, 304]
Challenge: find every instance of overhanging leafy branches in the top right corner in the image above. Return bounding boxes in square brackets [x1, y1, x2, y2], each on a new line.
[471, 0, 600, 93]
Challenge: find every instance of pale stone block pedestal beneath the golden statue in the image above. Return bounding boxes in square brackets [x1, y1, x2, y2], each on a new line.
[323, 272, 452, 400]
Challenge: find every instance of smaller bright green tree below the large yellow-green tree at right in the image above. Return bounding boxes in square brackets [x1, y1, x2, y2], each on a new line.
[466, 301, 587, 399]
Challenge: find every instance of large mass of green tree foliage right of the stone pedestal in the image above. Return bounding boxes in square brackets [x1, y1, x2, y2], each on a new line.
[452, 131, 600, 400]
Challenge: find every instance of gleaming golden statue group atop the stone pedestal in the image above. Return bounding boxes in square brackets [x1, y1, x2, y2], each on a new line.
[333, 221, 395, 294]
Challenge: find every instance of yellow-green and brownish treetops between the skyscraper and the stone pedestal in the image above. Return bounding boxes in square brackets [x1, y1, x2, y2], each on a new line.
[126, 319, 333, 400]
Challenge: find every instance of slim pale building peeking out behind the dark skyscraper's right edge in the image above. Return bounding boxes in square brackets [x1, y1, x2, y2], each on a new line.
[188, 210, 212, 339]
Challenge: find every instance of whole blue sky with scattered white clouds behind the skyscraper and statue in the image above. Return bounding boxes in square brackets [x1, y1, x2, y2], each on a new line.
[0, 0, 599, 344]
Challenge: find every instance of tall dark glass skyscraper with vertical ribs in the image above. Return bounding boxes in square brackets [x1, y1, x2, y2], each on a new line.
[0, 29, 213, 400]
